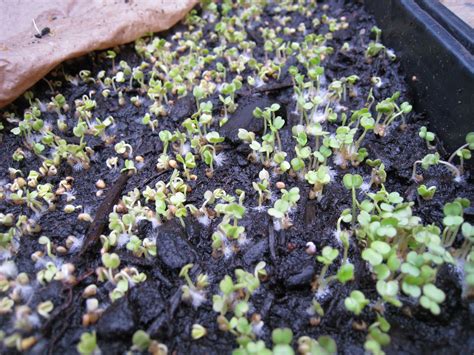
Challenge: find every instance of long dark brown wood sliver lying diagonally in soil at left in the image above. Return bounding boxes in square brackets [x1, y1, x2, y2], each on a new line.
[77, 172, 130, 261]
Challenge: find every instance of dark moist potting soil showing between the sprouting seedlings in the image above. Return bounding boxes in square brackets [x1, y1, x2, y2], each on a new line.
[0, 1, 474, 354]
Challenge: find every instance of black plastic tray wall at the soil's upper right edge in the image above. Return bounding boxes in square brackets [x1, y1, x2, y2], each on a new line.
[364, 0, 474, 155]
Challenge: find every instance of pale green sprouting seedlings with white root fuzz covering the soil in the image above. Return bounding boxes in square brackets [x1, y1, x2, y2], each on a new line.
[0, 0, 474, 355]
